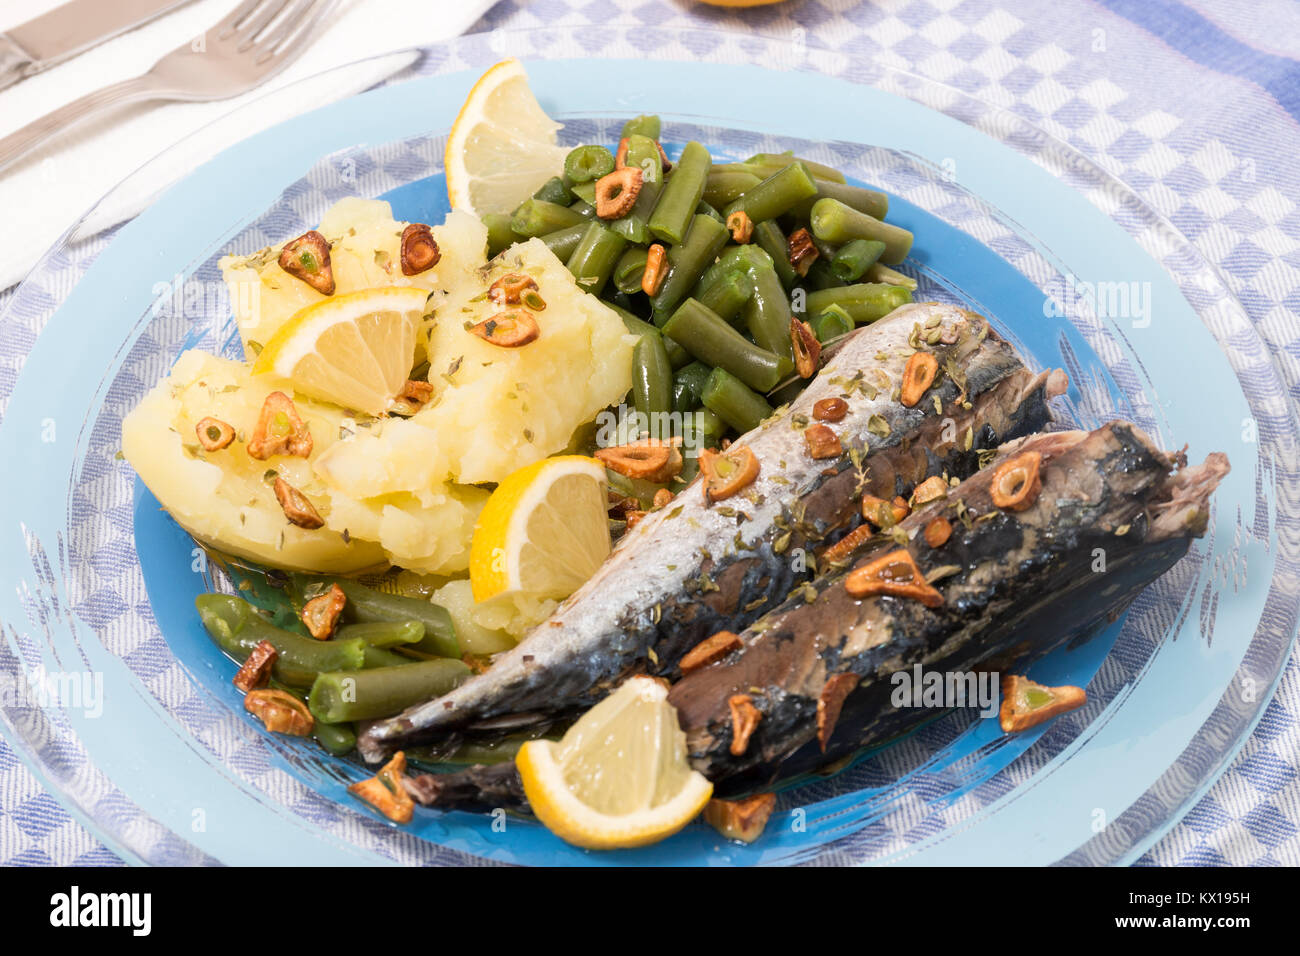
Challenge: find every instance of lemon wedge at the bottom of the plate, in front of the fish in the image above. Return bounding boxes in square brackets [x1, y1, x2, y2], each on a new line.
[515, 678, 714, 849]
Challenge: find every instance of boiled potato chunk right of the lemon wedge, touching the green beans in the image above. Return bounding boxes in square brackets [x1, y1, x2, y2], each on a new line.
[317, 239, 636, 498]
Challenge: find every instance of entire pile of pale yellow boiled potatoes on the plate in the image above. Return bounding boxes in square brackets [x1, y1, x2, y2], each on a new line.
[134, 199, 634, 580]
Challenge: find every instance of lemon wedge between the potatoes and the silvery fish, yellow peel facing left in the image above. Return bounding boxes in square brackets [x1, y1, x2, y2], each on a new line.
[469, 455, 610, 602]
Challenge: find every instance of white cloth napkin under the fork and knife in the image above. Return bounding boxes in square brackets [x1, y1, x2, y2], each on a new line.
[0, 0, 495, 290]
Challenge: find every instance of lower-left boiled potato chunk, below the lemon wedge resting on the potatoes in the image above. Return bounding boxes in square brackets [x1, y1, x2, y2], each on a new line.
[122, 351, 488, 574]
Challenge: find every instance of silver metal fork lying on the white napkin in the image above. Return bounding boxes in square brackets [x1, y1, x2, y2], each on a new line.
[0, 0, 335, 170]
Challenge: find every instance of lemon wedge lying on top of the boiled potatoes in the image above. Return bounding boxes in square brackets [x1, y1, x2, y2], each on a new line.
[252, 287, 429, 415]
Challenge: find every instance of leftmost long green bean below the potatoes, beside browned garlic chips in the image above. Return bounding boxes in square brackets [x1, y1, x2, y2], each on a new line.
[194, 594, 365, 687]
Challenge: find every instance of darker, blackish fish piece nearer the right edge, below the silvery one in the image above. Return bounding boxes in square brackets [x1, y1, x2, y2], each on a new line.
[668, 423, 1227, 796]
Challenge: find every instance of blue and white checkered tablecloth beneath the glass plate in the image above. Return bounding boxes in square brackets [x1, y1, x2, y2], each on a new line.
[0, 0, 1300, 865]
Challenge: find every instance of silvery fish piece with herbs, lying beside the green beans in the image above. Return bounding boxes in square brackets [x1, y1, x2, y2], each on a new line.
[358, 303, 1063, 762]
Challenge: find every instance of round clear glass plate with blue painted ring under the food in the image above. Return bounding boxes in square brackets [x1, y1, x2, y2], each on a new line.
[0, 29, 1300, 864]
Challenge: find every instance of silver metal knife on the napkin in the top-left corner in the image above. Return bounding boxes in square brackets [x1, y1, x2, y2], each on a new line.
[0, 0, 190, 90]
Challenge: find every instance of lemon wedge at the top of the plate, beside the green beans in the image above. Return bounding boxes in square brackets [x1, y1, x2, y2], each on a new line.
[443, 59, 568, 217]
